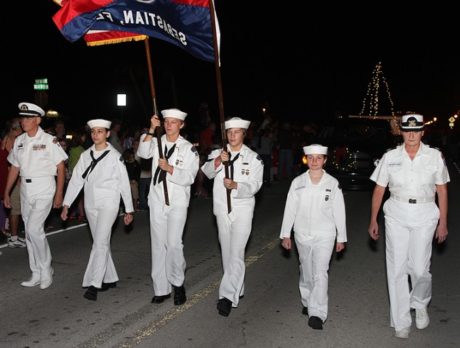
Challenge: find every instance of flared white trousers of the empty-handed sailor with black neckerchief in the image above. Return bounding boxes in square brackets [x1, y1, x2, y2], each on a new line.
[83, 199, 120, 288]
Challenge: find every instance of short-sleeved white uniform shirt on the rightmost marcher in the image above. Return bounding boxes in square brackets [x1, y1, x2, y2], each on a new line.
[371, 143, 450, 198]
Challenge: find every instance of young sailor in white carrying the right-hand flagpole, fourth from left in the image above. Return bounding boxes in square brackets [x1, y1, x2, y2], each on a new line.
[201, 117, 264, 316]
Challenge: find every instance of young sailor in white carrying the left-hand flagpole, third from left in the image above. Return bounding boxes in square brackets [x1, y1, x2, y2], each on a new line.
[137, 109, 199, 305]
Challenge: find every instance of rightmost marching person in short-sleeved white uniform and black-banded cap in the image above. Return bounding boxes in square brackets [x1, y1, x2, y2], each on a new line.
[368, 114, 450, 338]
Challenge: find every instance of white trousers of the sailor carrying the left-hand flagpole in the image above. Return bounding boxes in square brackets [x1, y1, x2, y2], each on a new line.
[149, 197, 187, 296]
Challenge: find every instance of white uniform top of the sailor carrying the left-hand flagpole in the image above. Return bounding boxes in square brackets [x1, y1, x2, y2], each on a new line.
[137, 134, 200, 207]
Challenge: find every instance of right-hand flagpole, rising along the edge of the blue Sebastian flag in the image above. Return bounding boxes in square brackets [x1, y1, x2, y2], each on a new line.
[209, 0, 232, 214]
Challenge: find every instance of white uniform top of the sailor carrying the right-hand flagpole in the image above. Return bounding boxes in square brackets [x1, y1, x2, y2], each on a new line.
[201, 144, 264, 215]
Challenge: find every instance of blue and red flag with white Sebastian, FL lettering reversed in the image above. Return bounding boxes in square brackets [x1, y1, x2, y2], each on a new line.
[53, 0, 214, 61]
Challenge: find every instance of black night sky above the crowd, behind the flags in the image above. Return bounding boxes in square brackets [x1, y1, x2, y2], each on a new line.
[0, 0, 460, 127]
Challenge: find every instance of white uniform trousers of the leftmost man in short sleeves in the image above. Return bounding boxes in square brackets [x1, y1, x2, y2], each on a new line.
[21, 176, 56, 281]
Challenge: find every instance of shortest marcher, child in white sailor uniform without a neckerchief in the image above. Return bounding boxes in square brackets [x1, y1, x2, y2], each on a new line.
[280, 144, 347, 330]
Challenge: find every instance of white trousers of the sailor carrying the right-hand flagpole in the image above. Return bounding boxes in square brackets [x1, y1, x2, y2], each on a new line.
[216, 207, 253, 307]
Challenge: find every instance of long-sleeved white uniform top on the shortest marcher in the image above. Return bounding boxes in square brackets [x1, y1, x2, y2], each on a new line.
[280, 171, 347, 243]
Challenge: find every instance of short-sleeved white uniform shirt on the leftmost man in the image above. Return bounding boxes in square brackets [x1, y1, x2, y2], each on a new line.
[8, 127, 67, 178]
